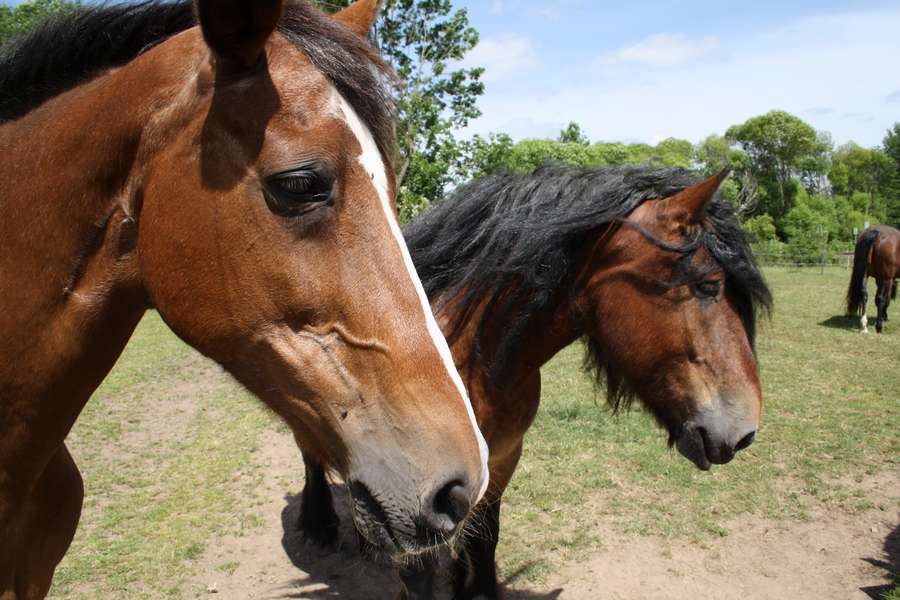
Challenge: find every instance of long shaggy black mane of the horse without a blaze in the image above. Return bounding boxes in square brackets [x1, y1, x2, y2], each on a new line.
[405, 165, 772, 406]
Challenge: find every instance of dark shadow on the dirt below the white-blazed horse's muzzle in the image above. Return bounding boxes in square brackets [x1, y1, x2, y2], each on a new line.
[271, 484, 562, 600]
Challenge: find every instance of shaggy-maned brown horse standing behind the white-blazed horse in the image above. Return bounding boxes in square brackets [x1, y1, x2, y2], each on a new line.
[300, 167, 771, 598]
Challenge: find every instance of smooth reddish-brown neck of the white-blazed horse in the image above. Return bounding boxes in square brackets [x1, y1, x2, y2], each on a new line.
[0, 32, 204, 433]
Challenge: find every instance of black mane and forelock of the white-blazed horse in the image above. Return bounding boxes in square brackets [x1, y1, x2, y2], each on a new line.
[0, 0, 394, 158]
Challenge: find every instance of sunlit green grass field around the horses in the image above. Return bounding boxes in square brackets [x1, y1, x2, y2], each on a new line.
[52, 269, 900, 600]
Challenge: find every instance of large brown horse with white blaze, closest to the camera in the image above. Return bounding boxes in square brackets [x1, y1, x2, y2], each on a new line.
[0, 0, 488, 600]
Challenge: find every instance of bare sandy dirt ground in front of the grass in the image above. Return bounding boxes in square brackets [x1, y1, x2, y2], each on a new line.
[184, 432, 900, 600]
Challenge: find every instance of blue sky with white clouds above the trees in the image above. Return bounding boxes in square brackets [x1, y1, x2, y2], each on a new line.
[0, 0, 900, 146]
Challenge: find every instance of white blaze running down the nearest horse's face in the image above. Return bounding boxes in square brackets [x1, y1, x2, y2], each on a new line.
[335, 92, 488, 500]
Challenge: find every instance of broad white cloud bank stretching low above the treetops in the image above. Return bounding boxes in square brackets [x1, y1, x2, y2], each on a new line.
[468, 7, 900, 146]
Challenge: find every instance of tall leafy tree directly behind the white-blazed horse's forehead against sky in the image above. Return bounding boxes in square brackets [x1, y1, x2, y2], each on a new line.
[320, 0, 484, 217]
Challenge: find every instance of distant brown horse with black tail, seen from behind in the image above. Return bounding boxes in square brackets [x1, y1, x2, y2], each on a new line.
[847, 225, 900, 333]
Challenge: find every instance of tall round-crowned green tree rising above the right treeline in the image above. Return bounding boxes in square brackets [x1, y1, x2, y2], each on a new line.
[725, 110, 828, 221]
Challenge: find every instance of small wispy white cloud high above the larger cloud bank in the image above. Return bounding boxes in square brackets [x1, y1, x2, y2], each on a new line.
[597, 33, 721, 67]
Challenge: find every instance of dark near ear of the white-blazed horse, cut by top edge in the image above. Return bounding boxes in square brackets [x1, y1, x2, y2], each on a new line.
[195, 0, 284, 72]
